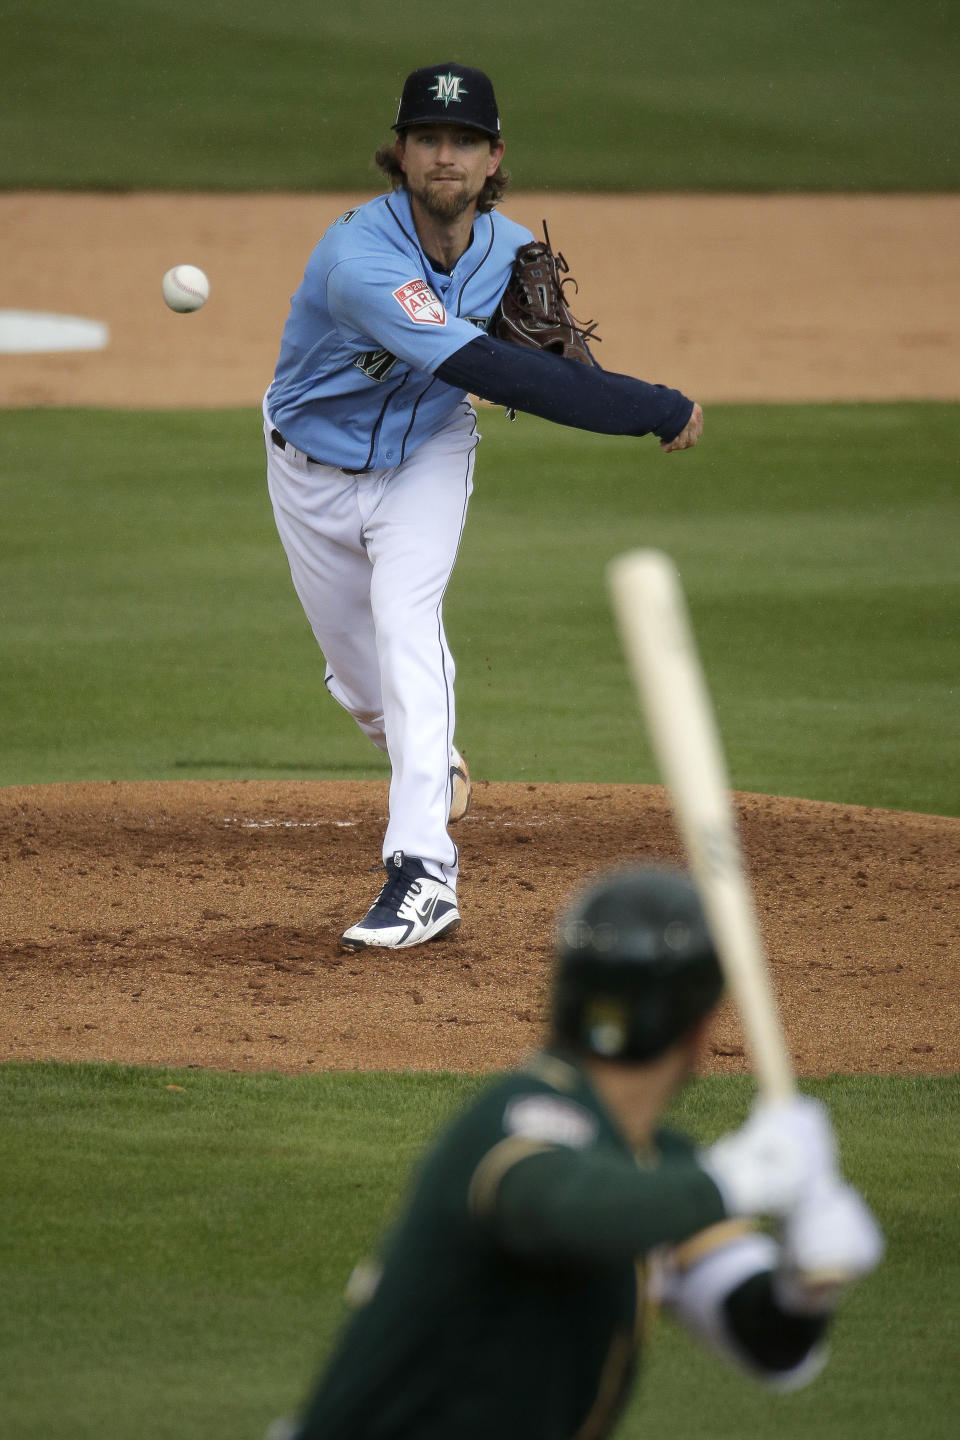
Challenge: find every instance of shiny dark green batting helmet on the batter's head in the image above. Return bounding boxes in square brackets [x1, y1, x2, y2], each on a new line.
[551, 868, 723, 1060]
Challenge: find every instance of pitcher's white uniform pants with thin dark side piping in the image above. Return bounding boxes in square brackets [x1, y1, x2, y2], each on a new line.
[263, 403, 479, 887]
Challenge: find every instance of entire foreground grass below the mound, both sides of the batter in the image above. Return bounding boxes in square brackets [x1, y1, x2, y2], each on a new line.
[0, 1064, 960, 1440]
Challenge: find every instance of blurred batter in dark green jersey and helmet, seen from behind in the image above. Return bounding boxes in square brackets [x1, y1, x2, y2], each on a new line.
[272, 868, 884, 1440]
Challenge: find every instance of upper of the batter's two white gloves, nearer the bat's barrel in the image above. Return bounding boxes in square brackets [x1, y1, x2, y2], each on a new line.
[699, 1094, 839, 1215]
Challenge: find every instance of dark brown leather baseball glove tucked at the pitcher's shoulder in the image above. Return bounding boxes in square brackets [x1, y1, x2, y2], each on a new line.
[492, 220, 600, 369]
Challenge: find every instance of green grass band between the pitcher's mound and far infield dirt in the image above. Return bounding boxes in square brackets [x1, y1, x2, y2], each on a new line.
[0, 405, 960, 815]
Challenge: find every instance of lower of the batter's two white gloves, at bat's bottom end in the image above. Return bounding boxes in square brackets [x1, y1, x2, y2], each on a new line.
[773, 1181, 884, 1315]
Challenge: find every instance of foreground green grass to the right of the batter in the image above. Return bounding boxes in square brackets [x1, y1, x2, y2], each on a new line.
[641, 1076, 960, 1440]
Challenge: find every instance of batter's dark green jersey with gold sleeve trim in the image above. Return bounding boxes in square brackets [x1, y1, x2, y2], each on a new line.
[298, 1053, 724, 1440]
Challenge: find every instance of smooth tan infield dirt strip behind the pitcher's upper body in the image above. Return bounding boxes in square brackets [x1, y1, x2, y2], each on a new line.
[0, 193, 960, 406]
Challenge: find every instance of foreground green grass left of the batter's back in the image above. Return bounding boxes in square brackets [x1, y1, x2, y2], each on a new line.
[0, 1066, 483, 1440]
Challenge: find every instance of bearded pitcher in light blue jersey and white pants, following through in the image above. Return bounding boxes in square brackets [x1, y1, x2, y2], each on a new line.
[263, 63, 702, 949]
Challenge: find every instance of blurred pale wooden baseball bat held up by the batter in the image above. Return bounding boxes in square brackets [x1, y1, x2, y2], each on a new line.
[607, 550, 794, 1099]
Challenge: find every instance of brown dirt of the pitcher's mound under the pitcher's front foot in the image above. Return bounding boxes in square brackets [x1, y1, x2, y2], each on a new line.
[0, 782, 960, 1074]
